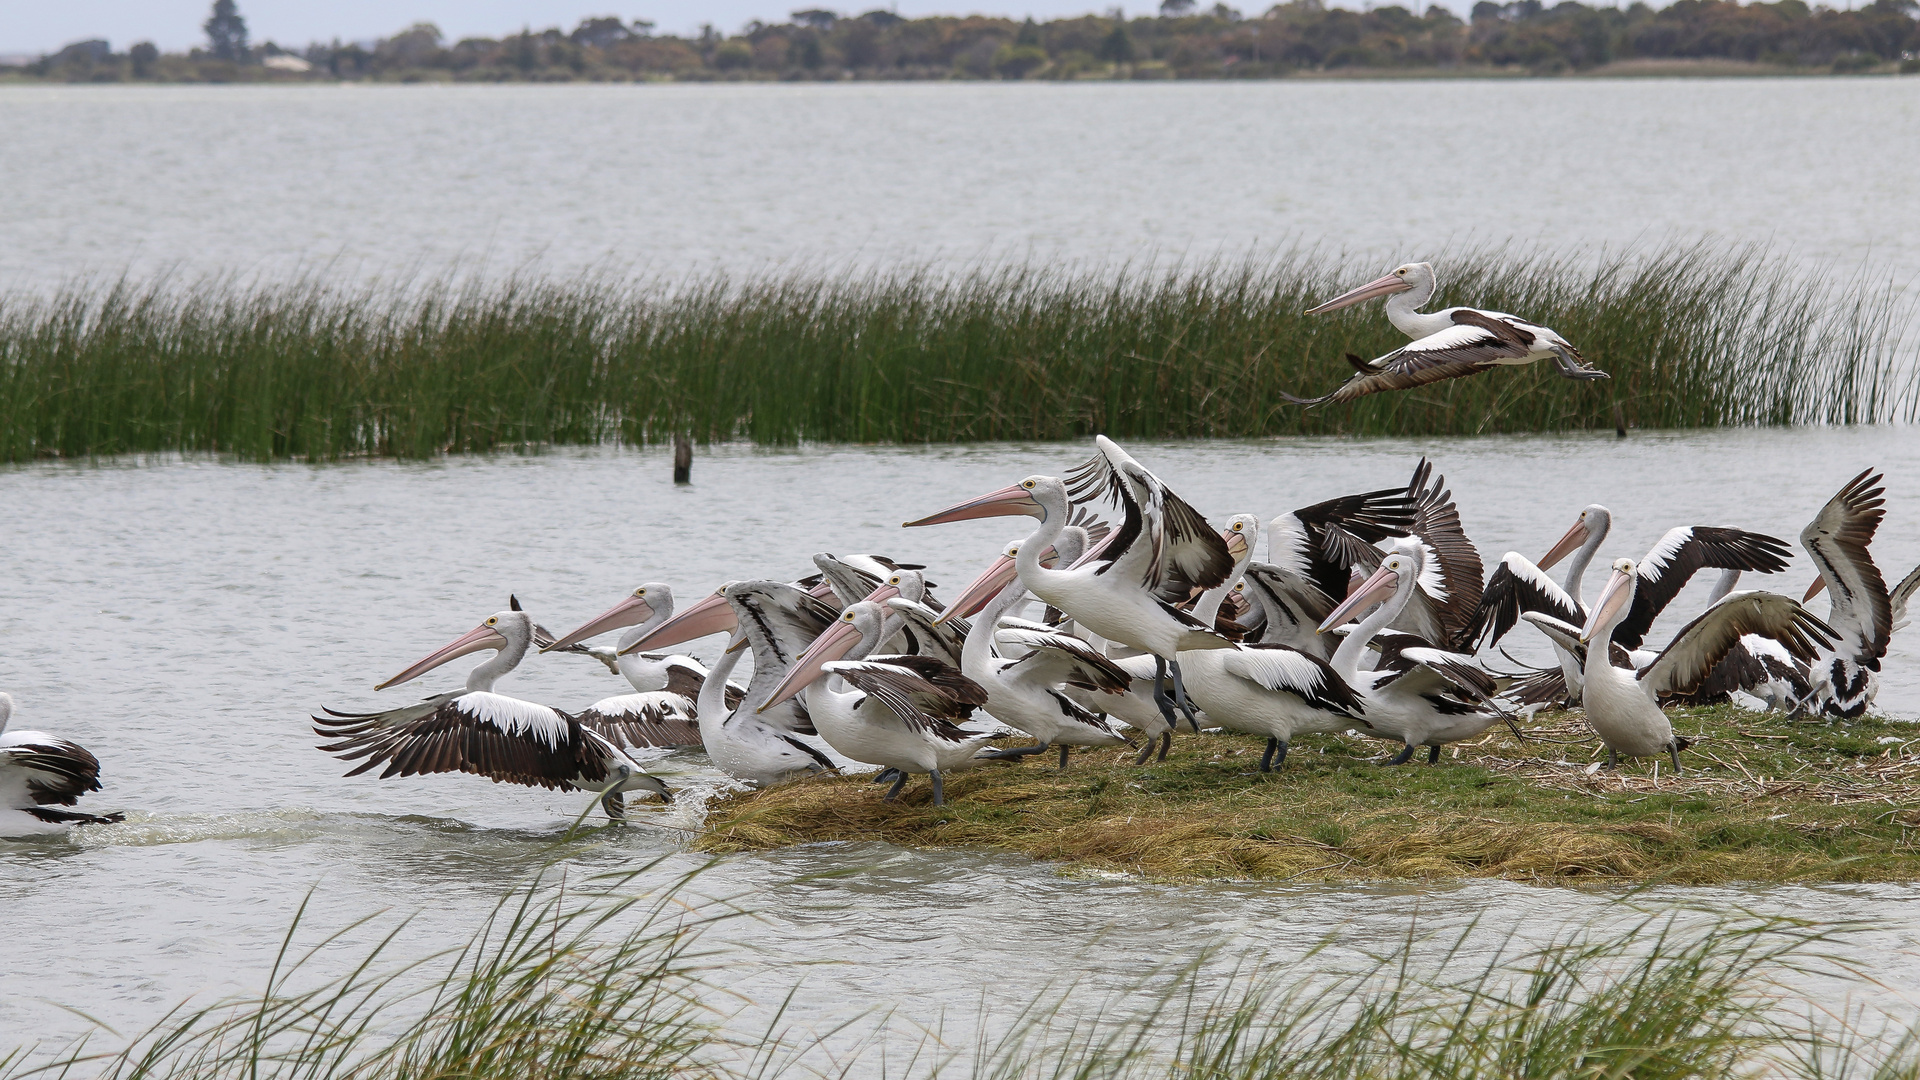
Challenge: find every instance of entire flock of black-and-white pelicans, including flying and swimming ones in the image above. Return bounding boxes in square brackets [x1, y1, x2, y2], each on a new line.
[0, 263, 1920, 836]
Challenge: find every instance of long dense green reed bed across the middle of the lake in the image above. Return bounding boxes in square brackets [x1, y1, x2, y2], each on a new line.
[0, 246, 1920, 461]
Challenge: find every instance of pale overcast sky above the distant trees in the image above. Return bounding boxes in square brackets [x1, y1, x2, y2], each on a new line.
[0, 0, 1467, 54]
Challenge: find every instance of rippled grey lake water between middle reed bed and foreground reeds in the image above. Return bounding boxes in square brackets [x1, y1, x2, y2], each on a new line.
[0, 429, 1920, 1047]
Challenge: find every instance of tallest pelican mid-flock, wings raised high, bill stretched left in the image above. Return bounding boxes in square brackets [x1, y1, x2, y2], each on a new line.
[906, 436, 1233, 726]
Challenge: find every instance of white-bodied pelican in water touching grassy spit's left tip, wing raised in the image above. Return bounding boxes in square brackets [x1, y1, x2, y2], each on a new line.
[630, 580, 835, 788]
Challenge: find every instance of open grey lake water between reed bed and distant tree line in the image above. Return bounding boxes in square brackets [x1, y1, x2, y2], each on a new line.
[0, 79, 1920, 292]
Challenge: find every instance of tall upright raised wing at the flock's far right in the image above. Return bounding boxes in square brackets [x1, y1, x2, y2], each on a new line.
[1801, 469, 1893, 663]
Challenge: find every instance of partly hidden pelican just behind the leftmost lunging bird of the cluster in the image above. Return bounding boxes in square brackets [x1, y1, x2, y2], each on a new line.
[540, 582, 743, 748]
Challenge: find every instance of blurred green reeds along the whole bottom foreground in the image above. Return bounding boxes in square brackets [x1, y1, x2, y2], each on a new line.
[11, 878, 1920, 1080]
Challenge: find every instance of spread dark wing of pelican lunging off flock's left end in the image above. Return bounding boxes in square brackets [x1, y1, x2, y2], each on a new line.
[313, 692, 618, 790]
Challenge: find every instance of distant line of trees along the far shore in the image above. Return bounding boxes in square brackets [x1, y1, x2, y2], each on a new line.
[17, 0, 1920, 83]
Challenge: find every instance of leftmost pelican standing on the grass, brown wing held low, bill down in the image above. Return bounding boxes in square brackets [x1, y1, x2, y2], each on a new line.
[760, 600, 993, 805]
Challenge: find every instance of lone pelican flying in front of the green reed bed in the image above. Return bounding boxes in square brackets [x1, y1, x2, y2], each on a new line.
[1281, 263, 1607, 405]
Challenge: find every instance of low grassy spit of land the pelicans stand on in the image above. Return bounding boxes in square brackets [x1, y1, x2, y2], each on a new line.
[697, 705, 1920, 884]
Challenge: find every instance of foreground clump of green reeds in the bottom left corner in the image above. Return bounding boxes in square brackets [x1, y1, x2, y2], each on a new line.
[0, 860, 729, 1080]
